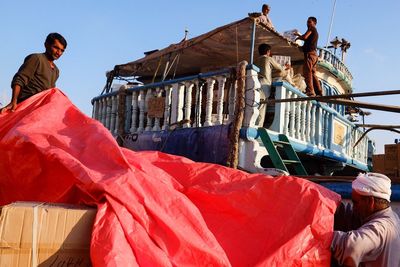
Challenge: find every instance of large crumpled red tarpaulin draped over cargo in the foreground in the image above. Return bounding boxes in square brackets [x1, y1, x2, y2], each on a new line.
[0, 89, 339, 267]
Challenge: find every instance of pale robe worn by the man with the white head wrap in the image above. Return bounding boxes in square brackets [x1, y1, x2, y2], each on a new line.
[331, 207, 400, 267]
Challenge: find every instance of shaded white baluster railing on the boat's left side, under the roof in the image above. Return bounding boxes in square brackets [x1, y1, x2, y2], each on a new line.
[92, 69, 236, 135]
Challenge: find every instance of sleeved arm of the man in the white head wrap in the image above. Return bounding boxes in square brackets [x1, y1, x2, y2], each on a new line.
[331, 223, 385, 266]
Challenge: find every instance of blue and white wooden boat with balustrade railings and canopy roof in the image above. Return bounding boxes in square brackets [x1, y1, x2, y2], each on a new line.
[92, 14, 374, 178]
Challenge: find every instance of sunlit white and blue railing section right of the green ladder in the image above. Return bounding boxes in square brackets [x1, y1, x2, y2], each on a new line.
[269, 82, 368, 164]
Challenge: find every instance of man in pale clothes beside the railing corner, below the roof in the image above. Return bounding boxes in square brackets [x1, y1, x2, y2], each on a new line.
[256, 43, 290, 127]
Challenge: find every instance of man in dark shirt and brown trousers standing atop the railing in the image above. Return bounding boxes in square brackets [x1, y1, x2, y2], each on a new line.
[295, 17, 322, 96]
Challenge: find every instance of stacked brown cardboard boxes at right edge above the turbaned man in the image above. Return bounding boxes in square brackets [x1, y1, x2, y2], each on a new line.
[372, 144, 400, 179]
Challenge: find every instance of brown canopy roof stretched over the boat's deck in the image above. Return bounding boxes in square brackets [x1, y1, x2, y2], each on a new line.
[112, 14, 303, 77]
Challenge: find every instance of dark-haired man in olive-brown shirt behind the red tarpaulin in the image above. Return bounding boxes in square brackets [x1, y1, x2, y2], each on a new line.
[1, 33, 67, 113]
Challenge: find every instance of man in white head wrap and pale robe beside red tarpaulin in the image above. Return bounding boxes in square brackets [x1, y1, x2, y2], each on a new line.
[331, 173, 400, 267]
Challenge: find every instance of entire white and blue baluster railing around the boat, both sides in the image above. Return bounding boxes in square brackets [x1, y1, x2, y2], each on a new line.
[92, 63, 368, 164]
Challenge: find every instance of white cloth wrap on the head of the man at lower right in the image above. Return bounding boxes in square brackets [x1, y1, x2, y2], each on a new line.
[351, 172, 392, 202]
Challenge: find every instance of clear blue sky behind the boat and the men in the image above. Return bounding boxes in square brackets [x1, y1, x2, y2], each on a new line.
[0, 0, 400, 153]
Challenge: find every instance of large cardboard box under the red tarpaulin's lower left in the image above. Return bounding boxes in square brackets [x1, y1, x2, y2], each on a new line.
[0, 202, 96, 267]
